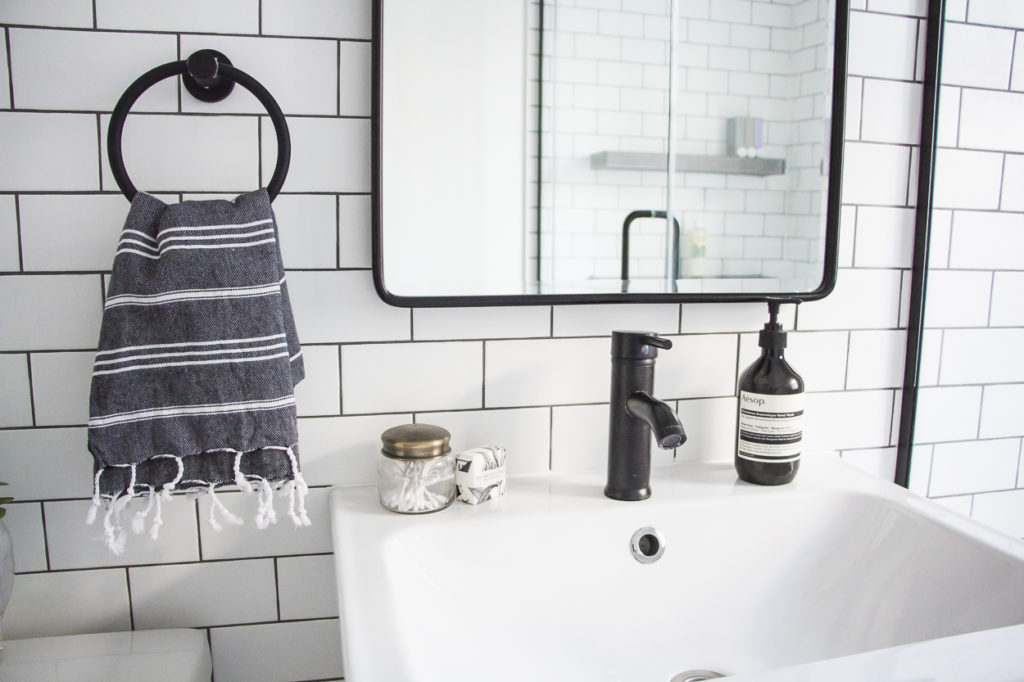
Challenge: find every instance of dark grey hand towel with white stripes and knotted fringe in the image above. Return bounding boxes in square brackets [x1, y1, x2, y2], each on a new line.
[88, 189, 309, 554]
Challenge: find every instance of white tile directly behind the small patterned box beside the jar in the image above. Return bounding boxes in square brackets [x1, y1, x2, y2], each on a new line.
[428, 408, 551, 475]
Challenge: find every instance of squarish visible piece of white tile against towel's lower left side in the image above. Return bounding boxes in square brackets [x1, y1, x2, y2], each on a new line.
[31, 350, 96, 426]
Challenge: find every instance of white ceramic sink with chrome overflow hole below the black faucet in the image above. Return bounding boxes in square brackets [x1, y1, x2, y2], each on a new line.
[331, 456, 1024, 682]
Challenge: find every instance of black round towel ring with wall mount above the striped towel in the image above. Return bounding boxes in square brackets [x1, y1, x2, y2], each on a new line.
[106, 50, 292, 201]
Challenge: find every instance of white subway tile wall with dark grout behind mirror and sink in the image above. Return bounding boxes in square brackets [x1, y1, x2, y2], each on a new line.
[0, 0, 1024, 682]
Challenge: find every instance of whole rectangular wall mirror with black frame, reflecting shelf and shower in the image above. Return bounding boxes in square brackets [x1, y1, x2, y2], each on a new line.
[373, 0, 849, 306]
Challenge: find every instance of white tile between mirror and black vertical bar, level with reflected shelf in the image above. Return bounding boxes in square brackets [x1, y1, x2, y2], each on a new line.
[843, 142, 910, 206]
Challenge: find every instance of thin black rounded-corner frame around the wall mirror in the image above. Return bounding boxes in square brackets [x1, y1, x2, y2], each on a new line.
[371, 0, 850, 308]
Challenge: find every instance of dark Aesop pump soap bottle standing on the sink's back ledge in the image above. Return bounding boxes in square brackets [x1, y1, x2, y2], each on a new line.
[735, 300, 804, 485]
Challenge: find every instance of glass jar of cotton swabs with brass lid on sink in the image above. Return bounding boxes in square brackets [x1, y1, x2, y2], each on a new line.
[377, 424, 455, 514]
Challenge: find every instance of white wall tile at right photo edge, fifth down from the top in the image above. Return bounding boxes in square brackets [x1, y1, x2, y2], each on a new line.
[949, 211, 1024, 270]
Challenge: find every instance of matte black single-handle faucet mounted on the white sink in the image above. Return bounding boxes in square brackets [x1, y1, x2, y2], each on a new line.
[604, 332, 686, 501]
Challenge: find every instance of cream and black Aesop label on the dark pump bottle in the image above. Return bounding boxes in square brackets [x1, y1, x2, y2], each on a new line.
[737, 391, 804, 462]
